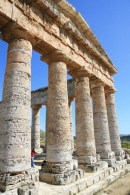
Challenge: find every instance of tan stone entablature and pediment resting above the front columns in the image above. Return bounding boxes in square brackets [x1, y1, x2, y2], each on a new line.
[0, 0, 117, 86]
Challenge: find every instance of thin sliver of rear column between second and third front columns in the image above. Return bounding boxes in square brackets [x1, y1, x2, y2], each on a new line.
[69, 98, 74, 153]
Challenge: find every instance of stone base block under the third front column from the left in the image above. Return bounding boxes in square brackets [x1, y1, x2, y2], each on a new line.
[78, 161, 108, 173]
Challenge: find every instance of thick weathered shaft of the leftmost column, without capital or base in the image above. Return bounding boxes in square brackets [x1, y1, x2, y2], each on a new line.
[0, 39, 32, 173]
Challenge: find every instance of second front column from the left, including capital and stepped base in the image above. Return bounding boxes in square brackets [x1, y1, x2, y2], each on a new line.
[40, 50, 84, 184]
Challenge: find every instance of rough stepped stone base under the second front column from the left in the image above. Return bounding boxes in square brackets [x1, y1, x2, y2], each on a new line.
[39, 160, 84, 185]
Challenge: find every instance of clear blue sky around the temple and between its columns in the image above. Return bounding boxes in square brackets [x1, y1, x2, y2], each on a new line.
[0, 0, 130, 134]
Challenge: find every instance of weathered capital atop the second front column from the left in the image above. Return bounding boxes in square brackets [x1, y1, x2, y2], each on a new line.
[40, 49, 70, 65]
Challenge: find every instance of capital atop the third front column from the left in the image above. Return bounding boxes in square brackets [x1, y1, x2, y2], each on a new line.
[68, 66, 91, 78]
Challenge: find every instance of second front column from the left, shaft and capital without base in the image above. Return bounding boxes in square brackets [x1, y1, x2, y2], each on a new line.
[42, 51, 72, 168]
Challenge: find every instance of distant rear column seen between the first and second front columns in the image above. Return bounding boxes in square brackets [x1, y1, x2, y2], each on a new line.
[31, 105, 41, 153]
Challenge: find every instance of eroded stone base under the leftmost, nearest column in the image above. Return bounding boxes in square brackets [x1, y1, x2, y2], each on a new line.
[0, 168, 39, 191]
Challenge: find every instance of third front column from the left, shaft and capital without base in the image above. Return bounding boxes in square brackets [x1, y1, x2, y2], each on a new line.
[70, 68, 97, 165]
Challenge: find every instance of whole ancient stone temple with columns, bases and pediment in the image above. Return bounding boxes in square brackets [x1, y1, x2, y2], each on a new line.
[0, 0, 128, 194]
